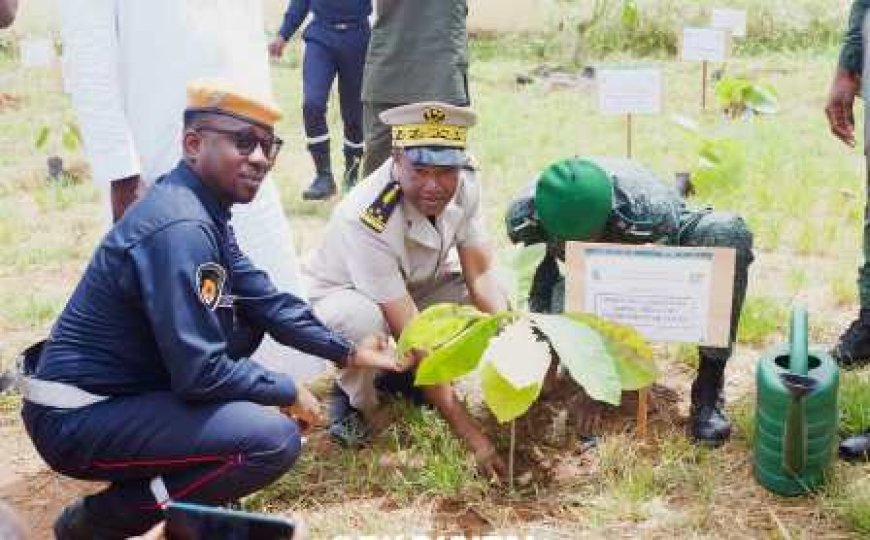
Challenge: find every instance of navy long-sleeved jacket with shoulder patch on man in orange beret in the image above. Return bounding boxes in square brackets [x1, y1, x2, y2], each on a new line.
[36, 163, 351, 405]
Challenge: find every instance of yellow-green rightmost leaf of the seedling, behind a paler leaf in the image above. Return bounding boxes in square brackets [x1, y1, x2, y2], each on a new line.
[565, 313, 659, 390]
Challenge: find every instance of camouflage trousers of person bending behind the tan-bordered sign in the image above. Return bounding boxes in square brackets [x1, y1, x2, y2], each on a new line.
[529, 210, 756, 362]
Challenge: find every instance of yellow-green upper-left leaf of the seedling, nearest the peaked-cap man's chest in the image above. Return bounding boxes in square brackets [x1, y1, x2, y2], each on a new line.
[397, 304, 484, 358]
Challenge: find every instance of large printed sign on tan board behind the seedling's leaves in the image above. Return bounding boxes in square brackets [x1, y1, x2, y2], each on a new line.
[565, 242, 735, 347]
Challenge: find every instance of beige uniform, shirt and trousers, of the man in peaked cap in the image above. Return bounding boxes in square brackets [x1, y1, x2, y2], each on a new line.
[303, 158, 488, 411]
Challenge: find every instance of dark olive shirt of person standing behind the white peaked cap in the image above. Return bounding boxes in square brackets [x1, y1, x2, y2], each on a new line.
[362, 0, 469, 105]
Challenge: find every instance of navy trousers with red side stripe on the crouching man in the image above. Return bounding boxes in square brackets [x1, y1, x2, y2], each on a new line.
[22, 334, 301, 538]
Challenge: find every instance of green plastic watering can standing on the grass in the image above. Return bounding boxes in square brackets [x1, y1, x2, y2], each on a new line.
[754, 306, 840, 496]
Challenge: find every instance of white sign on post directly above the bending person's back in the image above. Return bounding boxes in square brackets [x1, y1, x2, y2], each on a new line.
[596, 67, 662, 114]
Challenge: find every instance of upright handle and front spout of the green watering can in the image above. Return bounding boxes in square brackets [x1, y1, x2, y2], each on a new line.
[780, 306, 818, 475]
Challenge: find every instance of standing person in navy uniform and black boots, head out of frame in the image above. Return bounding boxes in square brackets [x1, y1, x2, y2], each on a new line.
[269, 0, 372, 200]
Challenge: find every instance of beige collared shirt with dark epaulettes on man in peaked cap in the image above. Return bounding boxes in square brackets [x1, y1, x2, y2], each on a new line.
[303, 158, 487, 303]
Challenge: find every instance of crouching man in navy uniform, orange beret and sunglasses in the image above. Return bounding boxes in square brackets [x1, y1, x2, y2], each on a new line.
[21, 83, 399, 539]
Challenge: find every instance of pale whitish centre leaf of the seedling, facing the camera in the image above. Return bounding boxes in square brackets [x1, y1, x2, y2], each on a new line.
[483, 317, 551, 388]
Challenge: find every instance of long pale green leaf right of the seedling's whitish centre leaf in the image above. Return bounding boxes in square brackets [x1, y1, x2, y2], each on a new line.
[531, 313, 622, 405]
